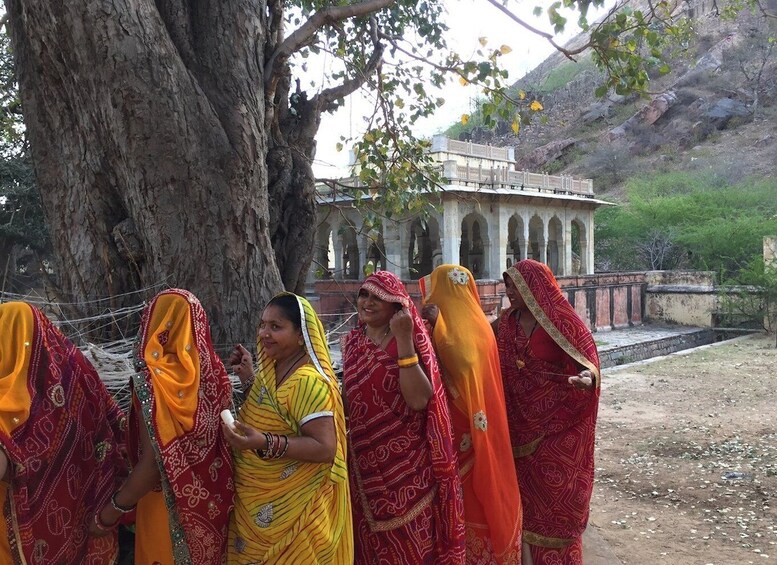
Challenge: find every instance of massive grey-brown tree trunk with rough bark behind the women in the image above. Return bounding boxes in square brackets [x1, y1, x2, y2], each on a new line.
[5, 0, 292, 351]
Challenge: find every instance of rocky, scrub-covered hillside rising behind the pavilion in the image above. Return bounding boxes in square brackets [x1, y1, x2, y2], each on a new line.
[449, 2, 777, 201]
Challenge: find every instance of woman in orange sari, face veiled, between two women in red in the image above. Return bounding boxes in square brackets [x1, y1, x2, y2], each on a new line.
[420, 265, 522, 565]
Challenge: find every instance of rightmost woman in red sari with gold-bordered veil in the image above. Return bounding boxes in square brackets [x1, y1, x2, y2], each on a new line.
[497, 259, 601, 565]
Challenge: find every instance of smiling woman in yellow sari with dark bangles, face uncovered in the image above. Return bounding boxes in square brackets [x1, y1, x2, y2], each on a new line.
[222, 293, 353, 565]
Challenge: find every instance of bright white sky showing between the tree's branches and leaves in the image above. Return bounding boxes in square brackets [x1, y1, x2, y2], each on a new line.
[306, 0, 603, 178]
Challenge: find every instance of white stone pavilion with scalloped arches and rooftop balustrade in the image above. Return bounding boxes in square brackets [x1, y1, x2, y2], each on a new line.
[309, 136, 607, 282]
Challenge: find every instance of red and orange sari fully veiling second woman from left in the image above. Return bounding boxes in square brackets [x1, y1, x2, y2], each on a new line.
[129, 289, 234, 565]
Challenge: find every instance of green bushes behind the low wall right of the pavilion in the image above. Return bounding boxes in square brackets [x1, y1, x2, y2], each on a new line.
[596, 173, 777, 280]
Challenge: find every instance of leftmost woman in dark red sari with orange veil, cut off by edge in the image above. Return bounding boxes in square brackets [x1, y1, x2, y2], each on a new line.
[0, 302, 127, 565]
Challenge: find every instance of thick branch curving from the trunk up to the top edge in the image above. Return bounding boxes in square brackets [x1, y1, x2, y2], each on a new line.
[264, 0, 396, 87]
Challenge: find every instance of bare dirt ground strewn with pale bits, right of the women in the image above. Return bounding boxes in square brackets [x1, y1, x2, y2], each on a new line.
[589, 335, 777, 565]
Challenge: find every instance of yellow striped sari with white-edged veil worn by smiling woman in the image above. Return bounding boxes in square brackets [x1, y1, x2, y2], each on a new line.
[228, 292, 353, 565]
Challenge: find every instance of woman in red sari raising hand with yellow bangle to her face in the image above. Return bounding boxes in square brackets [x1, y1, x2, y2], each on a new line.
[343, 271, 465, 565]
